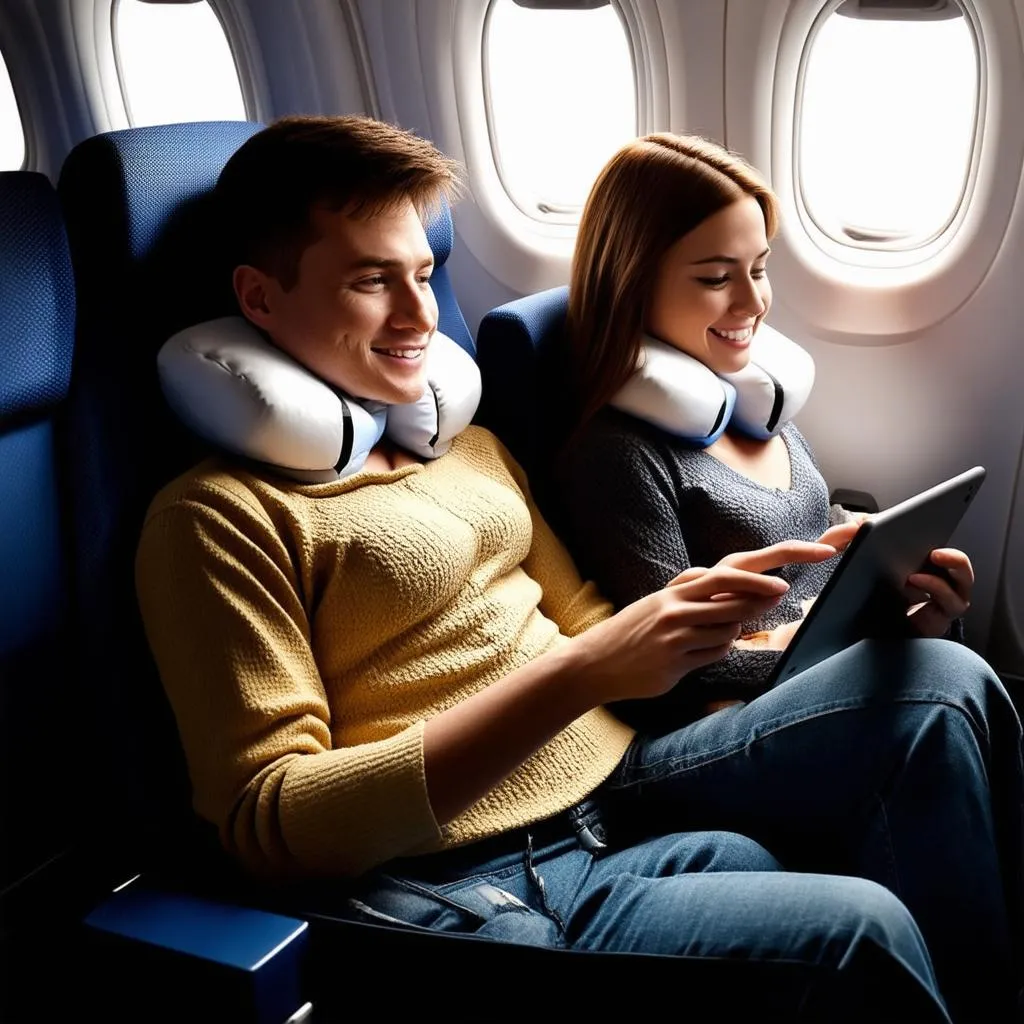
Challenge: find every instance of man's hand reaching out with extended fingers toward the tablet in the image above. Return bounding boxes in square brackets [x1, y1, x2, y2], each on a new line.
[572, 541, 836, 703]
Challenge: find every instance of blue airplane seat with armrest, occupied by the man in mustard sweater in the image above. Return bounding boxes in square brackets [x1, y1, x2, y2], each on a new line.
[57, 122, 696, 1021]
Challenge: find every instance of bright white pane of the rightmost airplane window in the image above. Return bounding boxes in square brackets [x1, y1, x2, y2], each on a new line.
[797, 0, 979, 250]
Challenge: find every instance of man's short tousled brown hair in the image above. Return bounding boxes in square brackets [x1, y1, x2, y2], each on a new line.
[215, 116, 460, 289]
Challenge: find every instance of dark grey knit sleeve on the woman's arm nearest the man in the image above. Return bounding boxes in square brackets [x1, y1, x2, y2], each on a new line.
[561, 435, 779, 708]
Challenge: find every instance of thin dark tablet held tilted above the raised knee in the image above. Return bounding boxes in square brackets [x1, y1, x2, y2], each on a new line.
[769, 466, 985, 686]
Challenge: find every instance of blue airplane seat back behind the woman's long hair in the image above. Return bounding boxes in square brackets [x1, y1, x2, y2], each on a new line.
[475, 286, 569, 536]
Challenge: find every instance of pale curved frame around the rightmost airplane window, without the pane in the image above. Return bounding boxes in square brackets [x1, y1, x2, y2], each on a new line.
[725, 0, 1024, 346]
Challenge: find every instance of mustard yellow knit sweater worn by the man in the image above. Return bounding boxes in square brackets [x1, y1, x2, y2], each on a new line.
[136, 427, 632, 876]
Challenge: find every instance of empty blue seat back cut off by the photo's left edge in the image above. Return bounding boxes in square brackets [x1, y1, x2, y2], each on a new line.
[0, 171, 75, 891]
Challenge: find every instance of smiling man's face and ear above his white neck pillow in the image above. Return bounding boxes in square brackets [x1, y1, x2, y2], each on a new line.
[234, 201, 437, 403]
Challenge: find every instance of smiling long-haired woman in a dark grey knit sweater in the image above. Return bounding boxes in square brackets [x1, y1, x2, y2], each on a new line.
[563, 134, 974, 712]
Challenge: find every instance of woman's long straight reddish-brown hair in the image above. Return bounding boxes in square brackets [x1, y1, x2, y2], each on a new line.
[566, 132, 778, 438]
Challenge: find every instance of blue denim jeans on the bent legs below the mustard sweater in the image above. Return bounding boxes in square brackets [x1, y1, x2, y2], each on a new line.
[357, 640, 1024, 1021]
